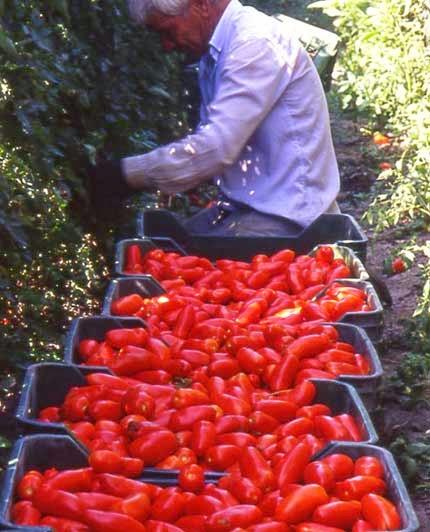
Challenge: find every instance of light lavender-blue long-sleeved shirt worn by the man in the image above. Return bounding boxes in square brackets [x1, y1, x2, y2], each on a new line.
[123, 0, 339, 226]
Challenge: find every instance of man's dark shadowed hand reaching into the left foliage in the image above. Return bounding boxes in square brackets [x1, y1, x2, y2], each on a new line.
[88, 161, 135, 219]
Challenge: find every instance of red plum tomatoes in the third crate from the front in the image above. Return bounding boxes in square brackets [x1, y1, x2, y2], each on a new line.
[74, 318, 371, 384]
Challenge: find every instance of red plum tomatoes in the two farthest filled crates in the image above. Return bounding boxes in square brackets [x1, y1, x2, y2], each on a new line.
[119, 244, 371, 328]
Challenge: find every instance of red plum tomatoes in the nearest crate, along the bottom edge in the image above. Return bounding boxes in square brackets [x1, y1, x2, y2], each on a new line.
[12, 447, 401, 532]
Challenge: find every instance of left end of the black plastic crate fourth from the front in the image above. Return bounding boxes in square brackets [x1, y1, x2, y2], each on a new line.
[102, 275, 166, 316]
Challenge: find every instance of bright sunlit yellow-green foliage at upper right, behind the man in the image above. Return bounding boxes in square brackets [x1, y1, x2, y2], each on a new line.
[312, 0, 430, 228]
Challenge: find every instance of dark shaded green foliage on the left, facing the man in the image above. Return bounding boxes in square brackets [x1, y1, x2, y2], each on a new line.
[0, 0, 184, 365]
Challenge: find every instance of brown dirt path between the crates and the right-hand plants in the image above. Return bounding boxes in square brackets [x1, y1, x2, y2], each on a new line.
[332, 116, 430, 532]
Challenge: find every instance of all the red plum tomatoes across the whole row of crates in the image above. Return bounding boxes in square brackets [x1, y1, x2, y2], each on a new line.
[12, 246, 401, 532]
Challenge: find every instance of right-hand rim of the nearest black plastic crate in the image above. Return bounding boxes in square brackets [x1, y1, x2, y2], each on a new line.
[315, 442, 424, 532]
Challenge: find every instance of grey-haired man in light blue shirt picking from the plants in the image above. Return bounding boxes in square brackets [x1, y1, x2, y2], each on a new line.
[93, 0, 339, 236]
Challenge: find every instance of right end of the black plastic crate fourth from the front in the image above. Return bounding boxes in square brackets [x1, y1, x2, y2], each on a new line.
[314, 279, 384, 342]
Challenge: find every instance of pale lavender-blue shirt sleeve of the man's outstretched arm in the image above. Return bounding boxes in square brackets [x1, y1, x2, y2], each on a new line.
[122, 37, 291, 194]
